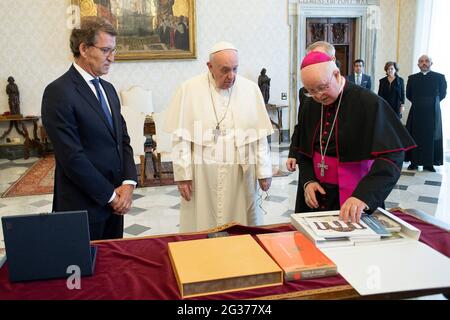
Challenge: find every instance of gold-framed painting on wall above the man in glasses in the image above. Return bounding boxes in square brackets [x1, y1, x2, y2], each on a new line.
[71, 0, 196, 60]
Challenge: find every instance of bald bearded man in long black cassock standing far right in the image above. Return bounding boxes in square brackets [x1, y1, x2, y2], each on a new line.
[405, 55, 447, 172]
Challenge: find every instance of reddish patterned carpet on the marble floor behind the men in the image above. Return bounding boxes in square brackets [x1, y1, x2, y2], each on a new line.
[2, 155, 290, 198]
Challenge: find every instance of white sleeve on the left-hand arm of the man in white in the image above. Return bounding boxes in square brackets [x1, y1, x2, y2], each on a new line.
[172, 139, 192, 181]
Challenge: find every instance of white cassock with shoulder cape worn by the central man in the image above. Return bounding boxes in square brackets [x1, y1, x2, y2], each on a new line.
[165, 72, 273, 232]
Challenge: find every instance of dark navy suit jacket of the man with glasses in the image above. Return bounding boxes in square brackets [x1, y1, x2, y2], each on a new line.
[42, 66, 137, 223]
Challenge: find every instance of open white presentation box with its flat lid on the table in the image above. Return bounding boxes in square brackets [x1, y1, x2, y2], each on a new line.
[291, 208, 450, 295]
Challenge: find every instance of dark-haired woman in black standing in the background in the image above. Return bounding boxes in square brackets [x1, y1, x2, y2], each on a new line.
[378, 61, 405, 118]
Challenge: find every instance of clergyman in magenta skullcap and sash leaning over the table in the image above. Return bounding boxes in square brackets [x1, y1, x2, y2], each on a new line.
[293, 52, 415, 222]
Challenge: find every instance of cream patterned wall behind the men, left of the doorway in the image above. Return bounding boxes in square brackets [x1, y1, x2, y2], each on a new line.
[0, 0, 289, 138]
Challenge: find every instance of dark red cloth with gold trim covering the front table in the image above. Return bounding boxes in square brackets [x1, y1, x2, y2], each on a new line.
[0, 210, 450, 300]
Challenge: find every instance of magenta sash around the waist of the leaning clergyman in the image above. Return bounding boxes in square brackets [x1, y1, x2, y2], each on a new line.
[313, 152, 373, 206]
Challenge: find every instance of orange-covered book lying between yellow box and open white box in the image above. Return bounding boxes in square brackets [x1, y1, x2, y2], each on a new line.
[257, 231, 337, 281]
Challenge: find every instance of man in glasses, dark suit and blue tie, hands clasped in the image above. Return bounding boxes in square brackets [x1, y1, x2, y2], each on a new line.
[42, 17, 137, 240]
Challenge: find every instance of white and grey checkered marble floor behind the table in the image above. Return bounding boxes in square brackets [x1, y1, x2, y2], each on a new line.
[0, 143, 450, 248]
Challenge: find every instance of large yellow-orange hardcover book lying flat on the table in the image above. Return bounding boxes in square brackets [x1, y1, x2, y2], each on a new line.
[168, 235, 283, 298]
